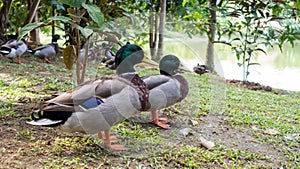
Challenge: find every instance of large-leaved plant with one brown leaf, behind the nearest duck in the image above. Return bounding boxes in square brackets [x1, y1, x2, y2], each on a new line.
[19, 0, 104, 83]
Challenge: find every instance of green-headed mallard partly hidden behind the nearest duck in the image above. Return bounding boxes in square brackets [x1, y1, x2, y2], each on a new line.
[143, 55, 189, 129]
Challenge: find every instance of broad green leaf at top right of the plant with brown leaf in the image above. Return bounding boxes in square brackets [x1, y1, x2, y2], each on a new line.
[82, 4, 104, 27]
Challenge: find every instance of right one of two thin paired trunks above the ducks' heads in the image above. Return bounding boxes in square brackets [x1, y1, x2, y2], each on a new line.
[154, 0, 167, 61]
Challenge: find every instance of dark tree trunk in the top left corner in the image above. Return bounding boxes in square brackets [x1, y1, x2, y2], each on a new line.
[0, 0, 13, 41]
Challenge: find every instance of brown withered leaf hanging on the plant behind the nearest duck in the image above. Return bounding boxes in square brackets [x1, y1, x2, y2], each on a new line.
[62, 45, 77, 70]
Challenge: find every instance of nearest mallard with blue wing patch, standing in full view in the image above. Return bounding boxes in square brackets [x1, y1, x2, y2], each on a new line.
[27, 44, 157, 150]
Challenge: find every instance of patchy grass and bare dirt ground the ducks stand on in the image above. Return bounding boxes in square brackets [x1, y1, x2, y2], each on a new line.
[0, 57, 300, 168]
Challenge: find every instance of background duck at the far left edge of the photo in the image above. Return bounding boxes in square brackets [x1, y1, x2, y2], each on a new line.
[0, 36, 27, 64]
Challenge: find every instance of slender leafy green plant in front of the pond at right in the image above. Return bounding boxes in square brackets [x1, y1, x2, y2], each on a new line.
[216, 0, 300, 81]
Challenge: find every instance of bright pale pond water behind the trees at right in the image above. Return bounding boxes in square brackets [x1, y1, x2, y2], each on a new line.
[159, 38, 300, 91]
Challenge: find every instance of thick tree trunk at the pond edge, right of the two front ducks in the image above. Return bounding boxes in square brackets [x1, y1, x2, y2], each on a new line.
[205, 0, 217, 71]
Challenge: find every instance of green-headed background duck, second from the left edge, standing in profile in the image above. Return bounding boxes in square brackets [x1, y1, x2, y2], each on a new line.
[27, 34, 60, 63]
